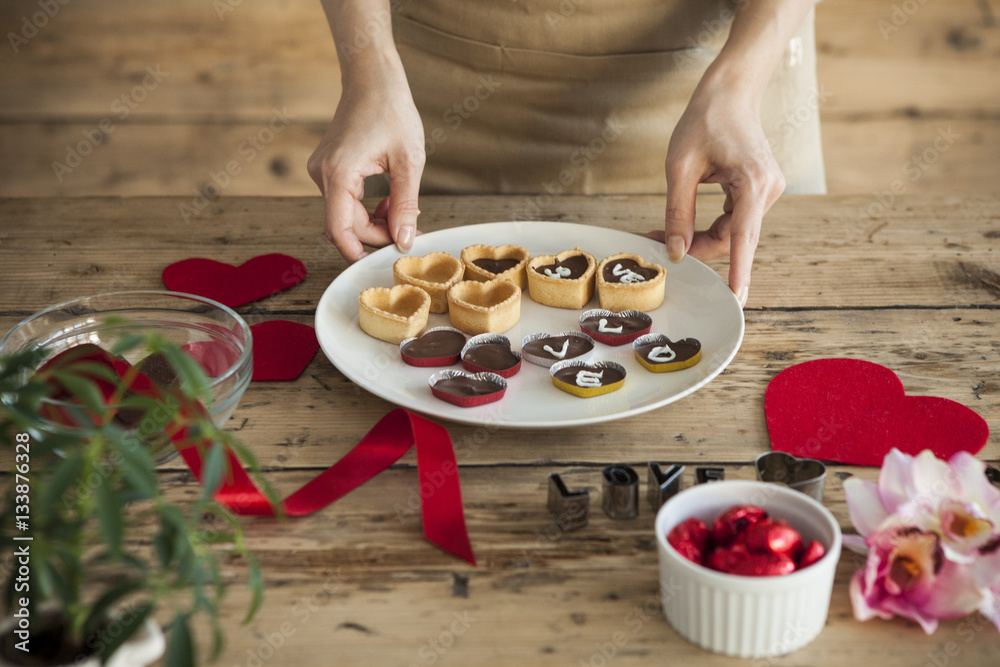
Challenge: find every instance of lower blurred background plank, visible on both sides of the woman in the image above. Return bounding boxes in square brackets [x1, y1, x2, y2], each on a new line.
[0, 117, 1000, 197]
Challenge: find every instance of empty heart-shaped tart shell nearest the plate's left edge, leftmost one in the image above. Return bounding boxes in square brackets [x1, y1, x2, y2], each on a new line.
[358, 285, 431, 345]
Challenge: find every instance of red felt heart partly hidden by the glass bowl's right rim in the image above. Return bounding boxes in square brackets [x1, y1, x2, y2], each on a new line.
[250, 320, 319, 382]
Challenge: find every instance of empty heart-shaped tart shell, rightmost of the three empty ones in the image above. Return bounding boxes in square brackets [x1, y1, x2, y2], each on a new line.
[448, 280, 521, 336]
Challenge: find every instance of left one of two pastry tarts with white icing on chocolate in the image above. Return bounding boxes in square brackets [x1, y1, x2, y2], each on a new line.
[527, 248, 597, 308]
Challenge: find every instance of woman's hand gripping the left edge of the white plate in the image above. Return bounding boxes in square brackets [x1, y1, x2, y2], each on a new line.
[307, 52, 425, 262]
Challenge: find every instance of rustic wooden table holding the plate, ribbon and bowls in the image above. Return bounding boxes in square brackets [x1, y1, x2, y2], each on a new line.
[0, 196, 1000, 667]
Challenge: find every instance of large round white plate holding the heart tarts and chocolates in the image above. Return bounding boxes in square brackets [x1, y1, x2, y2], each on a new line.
[316, 222, 744, 428]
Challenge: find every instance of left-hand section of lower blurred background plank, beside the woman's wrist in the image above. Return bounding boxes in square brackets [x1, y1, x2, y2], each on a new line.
[0, 122, 325, 197]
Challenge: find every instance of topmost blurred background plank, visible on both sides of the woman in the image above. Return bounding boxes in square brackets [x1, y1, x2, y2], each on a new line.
[0, 0, 1000, 122]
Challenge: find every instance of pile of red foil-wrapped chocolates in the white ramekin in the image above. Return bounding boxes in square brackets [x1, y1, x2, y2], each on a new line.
[667, 505, 826, 577]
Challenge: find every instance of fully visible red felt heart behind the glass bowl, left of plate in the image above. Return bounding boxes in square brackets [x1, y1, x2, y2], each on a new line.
[163, 253, 306, 308]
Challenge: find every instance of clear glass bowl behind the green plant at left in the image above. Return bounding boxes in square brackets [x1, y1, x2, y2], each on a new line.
[0, 290, 253, 463]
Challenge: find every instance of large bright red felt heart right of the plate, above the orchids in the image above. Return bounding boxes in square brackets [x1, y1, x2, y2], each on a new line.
[764, 359, 989, 466]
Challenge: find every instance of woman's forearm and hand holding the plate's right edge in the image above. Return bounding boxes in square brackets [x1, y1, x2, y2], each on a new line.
[650, 0, 815, 305]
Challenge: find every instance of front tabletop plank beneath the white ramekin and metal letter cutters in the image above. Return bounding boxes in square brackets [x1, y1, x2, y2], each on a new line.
[146, 468, 1000, 666]
